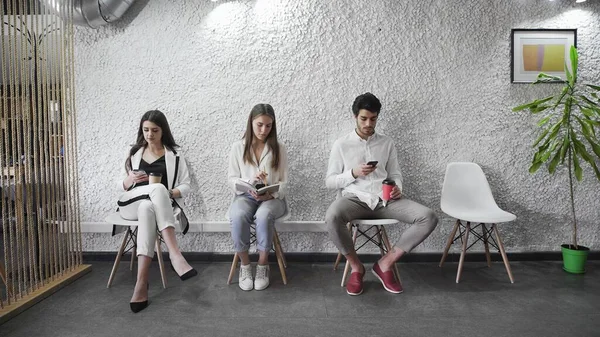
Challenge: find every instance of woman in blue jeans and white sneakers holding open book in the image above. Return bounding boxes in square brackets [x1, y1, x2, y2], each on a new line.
[228, 104, 288, 291]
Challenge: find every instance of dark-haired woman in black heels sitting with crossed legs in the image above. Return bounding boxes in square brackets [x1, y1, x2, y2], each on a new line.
[118, 110, 197, 312]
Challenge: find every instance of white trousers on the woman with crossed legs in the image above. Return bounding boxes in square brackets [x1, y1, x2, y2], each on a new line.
[118, 184, 175, 258]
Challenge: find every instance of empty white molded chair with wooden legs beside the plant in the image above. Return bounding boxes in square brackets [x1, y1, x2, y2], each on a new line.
[440, 162, 517, 283]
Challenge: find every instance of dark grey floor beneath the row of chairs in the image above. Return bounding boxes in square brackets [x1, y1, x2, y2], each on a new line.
[0, 261, 600, 337]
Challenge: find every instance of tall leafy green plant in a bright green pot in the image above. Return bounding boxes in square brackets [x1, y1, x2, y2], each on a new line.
[513, 47, 600, 273]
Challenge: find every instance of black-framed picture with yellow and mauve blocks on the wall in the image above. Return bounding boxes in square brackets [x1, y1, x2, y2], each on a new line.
[510, 29, 577, 83]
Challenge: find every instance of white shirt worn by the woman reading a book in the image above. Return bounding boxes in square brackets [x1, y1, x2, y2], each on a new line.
[228, 140, 288, 199]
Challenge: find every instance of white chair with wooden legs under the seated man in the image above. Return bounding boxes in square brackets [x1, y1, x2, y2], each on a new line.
[333, 219, 402, 287]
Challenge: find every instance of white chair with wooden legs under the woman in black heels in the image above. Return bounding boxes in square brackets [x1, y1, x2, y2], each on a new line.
[104, 212, 167, 288]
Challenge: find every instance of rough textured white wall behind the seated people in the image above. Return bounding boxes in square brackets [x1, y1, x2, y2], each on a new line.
[75, 0, 600, 252]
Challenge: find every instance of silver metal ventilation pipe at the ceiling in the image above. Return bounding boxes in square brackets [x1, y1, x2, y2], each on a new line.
[42, 0, 135, 28]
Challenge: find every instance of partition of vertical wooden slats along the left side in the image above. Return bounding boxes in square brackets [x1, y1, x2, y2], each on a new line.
[0, 0, 90, 323]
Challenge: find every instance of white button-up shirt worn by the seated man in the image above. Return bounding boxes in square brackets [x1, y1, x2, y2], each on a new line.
[325, 130, 402, 209]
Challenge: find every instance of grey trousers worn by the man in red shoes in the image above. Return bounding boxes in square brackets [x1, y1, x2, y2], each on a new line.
[325, 197, 438, 255]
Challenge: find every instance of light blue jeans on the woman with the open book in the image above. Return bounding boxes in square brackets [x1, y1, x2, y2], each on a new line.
[229, 194, 286, 252]
